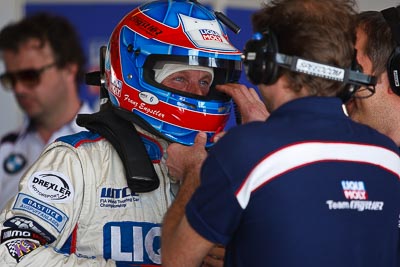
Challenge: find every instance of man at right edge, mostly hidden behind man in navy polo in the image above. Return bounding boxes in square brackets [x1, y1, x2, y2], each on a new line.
[346, 6, 400, 147]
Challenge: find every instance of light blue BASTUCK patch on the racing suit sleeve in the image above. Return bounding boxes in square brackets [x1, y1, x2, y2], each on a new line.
[13, 193, 69, 233]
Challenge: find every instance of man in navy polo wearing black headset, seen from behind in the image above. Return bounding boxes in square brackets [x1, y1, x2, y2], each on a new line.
[161, 0, 400, 267]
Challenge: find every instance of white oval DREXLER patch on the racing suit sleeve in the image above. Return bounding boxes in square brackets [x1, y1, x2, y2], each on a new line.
[28, 171, 74, 203]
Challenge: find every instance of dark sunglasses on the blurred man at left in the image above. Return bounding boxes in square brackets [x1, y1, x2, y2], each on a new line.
[0, 62, 56, 90]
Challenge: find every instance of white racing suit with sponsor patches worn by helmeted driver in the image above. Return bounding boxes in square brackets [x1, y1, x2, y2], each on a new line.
[0, 126, 176, 267]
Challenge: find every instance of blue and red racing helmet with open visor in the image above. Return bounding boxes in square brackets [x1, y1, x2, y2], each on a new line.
[105, 0, 242, 146]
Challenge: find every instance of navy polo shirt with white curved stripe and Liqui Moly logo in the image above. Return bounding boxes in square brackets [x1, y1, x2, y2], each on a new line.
[186, 97, 400, 267]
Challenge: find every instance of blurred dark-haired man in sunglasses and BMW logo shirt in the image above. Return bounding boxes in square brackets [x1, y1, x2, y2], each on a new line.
[0, 13, 92, 210]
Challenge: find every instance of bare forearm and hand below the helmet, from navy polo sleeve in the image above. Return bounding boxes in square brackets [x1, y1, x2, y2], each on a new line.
[161, 133, 216, 267]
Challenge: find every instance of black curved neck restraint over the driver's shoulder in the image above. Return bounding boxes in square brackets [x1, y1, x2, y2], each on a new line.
[76, 102, 160, 193]
